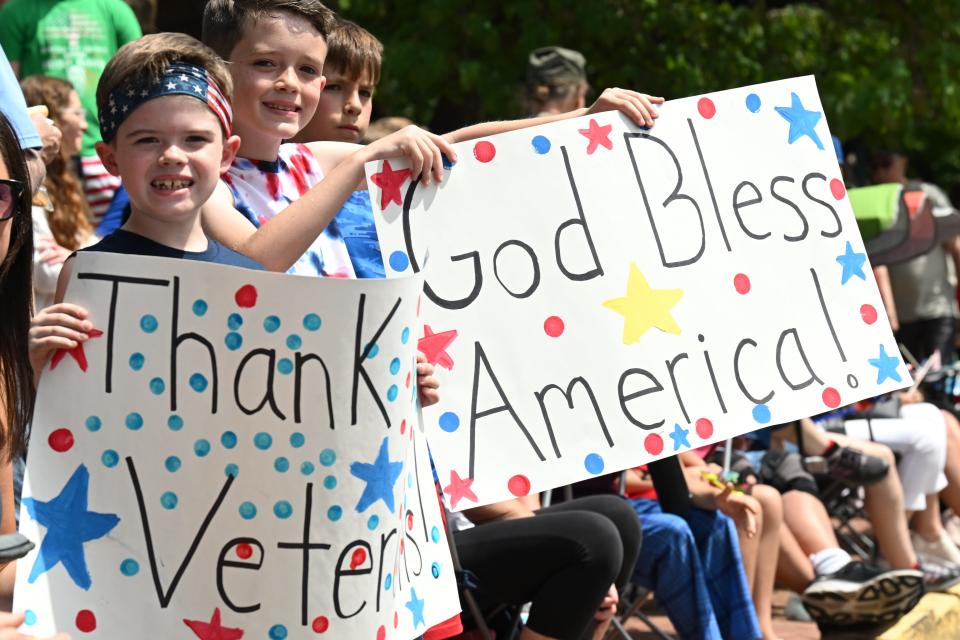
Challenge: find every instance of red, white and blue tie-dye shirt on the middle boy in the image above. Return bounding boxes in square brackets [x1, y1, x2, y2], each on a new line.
[223, 143, 356, 278]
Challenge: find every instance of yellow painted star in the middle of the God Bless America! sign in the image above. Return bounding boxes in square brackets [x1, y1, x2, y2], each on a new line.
[603, 262, 683, 344]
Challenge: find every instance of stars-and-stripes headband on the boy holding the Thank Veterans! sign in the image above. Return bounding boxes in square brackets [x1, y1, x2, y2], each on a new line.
[100, 62, 233, 142]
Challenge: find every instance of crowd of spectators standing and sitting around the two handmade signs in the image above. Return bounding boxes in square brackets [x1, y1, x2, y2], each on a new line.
[0, 0, 960, 640]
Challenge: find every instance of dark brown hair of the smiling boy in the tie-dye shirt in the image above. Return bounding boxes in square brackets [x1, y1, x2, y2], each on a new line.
[201, 0, 336, 60]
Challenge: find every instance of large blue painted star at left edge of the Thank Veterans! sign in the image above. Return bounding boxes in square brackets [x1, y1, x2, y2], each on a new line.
[23, 465, 120, 590]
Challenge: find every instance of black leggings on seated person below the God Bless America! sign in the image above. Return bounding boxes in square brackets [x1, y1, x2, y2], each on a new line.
[454, 495, 640, 640]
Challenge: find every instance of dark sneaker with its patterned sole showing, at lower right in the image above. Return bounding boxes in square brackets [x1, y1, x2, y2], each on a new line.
[803, 560, 924, 627]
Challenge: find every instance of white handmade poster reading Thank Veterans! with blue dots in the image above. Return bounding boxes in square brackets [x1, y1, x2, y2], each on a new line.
[16, 254, 459, 640]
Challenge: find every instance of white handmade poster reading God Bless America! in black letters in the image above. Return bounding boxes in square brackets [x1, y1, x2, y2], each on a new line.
[367, 77, 910, 509]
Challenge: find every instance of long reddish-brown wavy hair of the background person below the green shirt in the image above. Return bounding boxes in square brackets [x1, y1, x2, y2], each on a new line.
[20, 76, 93, 250]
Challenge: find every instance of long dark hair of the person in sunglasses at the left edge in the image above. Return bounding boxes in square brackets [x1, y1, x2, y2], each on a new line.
[0, 113, 34, 461]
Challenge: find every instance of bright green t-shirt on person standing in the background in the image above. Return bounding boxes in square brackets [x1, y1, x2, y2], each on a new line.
[0, 0, 143, 156]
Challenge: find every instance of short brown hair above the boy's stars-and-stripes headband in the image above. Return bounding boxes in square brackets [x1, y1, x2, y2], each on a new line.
[97, 33, 233, 121]
